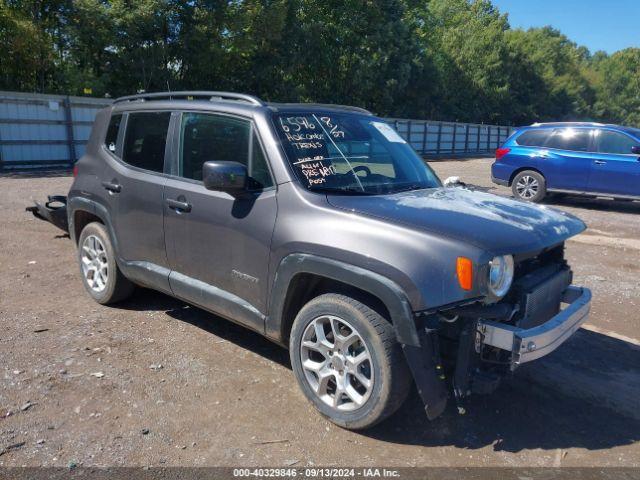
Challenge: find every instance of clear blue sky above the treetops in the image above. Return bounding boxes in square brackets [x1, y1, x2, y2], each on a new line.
[492, 0, 640, 53]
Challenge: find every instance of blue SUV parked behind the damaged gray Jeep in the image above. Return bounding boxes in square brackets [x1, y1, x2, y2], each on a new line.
[491, 122, 640, 202]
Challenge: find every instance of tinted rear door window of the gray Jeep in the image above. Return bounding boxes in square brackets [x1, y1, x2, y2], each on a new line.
[122, 112, 171, 172]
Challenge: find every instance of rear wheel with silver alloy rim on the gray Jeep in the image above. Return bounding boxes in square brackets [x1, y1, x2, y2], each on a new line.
[78, 222, 134, 305]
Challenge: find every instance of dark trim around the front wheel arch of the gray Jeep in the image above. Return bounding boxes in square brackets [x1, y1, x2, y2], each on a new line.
[265, 253, 420, 347]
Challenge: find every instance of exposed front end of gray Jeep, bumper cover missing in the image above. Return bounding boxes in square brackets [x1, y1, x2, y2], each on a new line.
[404, 245, 591, 419]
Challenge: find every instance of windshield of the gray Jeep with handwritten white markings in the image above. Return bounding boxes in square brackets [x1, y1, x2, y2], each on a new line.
[274, 112, 441, 195]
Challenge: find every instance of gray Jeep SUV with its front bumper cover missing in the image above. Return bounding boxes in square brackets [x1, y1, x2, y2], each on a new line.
[67, 92, 591, 429]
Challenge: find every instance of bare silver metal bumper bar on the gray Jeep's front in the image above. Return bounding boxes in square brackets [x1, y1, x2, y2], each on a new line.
[477, 285, 591, 369]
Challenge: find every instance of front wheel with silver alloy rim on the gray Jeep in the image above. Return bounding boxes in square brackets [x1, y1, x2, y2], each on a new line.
[289, 293, 411, 430]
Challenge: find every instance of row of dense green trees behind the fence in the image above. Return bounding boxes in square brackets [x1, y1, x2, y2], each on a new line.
[0, 0, 640, 125]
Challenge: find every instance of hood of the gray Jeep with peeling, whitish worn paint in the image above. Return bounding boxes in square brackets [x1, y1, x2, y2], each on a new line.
[327, 188, 586, 255]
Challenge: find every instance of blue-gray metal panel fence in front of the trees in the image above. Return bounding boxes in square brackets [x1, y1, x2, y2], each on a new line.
[0, 91, 513, 171]
